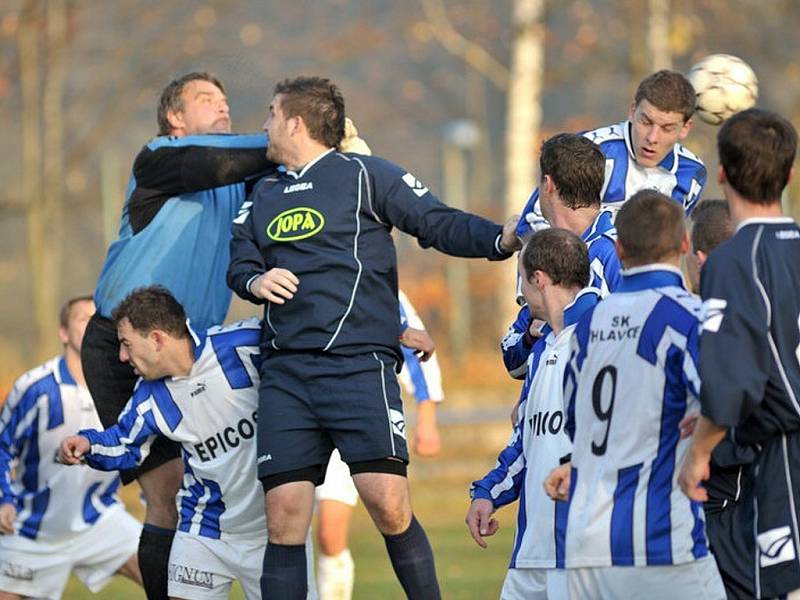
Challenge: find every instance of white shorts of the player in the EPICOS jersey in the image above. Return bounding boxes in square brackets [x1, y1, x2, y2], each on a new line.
[168, 531, 317, 600]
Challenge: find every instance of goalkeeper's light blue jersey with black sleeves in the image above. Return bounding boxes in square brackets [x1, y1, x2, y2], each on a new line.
[95, 134, 274, 330]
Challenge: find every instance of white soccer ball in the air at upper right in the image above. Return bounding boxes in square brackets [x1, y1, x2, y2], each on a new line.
[688, 54, 758, 125]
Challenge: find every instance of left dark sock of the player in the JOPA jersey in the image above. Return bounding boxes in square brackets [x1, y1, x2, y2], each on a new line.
[261, 542, 308, 600]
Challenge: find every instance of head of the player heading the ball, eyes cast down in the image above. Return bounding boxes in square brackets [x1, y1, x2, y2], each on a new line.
[628, 70, 695, 167]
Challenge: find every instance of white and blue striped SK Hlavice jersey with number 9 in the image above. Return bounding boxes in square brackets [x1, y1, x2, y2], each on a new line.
[564, 265, 708, 568]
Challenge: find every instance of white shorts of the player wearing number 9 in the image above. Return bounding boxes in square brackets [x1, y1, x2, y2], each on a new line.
[567, 554, 726, 600]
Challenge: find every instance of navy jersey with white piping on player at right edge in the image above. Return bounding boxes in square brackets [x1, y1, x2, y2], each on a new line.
[700, 218, 800, 444]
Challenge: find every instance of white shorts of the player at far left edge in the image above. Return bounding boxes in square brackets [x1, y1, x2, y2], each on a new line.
[0, 503, 142, 600]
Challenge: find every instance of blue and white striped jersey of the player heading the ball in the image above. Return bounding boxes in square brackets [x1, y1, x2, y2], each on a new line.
[517, 121, 707, 237]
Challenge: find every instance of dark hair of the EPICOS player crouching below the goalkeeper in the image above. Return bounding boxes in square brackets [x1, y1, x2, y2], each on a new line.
[111, 285, 189, 338]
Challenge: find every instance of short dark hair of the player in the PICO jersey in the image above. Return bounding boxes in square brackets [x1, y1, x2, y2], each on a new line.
[522, 228, 589, 287]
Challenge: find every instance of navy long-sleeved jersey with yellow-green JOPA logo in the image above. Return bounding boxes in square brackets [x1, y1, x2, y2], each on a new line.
[228, 150, 508, 360]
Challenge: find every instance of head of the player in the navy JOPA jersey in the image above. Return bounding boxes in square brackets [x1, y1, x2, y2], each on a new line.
[264, 77, 345, 163]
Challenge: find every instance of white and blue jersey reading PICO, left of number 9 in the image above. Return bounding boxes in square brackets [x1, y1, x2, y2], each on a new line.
[471, 288, 600, 569]
